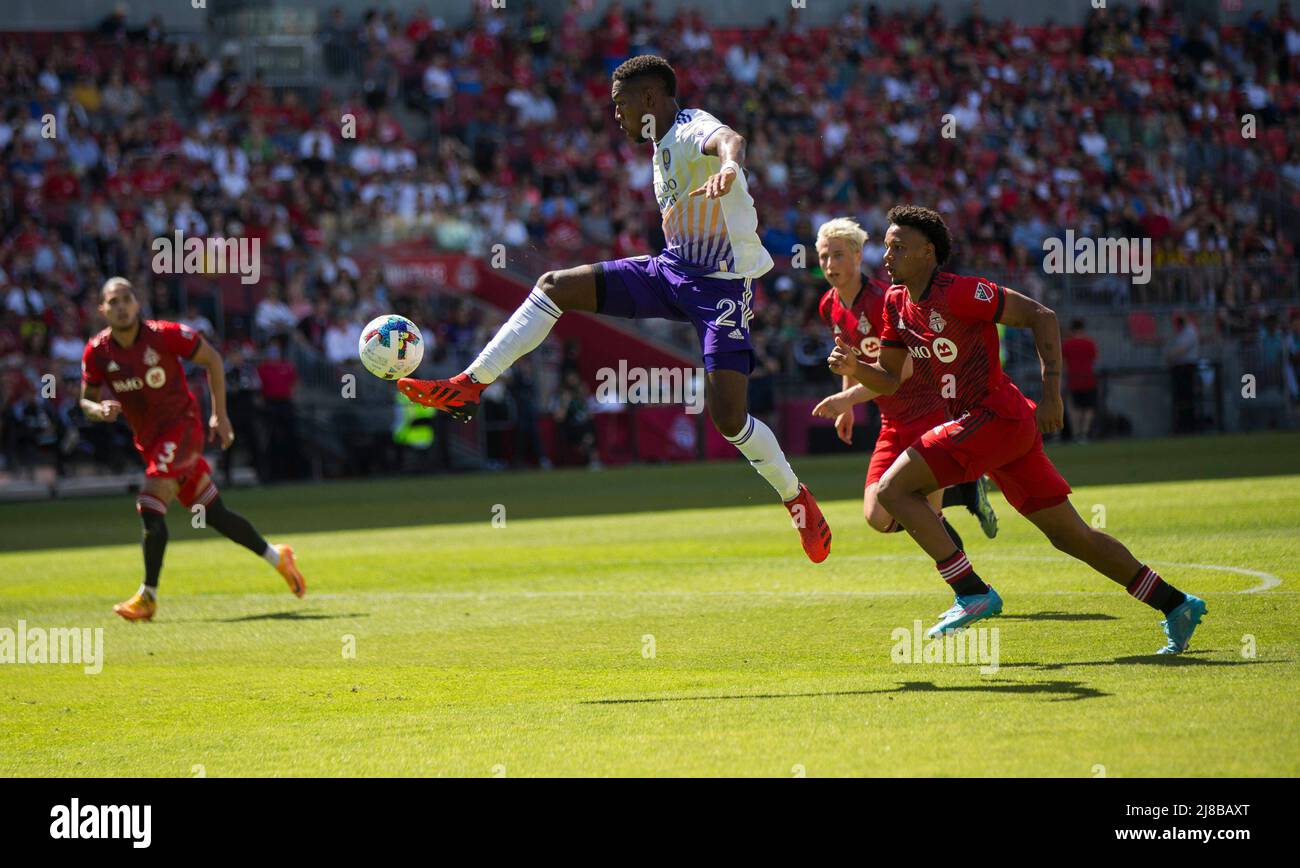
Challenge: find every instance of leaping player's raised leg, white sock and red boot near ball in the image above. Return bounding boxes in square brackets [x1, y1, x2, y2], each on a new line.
[398, 265, 597, 422]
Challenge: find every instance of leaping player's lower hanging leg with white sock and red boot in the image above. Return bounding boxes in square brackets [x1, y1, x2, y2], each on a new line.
[705, 366, 831, 564]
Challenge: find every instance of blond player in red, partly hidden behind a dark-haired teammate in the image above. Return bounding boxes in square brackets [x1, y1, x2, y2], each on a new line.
[813, 217, 997, 547]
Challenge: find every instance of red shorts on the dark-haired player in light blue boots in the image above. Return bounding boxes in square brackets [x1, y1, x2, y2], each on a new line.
[917, 407, 1070, 516]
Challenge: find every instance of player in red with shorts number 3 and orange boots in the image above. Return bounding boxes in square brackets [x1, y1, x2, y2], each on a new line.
[81, 277, 307, 621]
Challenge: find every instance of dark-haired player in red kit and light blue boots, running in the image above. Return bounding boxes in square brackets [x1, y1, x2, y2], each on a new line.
[828, 205, 1205, 654]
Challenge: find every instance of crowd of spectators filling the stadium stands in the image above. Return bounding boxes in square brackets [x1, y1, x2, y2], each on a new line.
[0, 0, 1300, 475]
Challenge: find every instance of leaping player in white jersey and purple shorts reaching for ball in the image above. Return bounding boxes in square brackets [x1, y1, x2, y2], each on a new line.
[398, 55, 831, 563]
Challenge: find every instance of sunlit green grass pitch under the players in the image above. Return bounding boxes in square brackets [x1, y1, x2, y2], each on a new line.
[0, 434, 1300, 777]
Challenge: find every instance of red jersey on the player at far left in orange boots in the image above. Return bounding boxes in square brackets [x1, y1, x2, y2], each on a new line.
[82, 320, 200, 448]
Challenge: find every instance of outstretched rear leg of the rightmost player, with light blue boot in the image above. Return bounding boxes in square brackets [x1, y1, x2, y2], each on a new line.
[1024, 500, 1206, 654]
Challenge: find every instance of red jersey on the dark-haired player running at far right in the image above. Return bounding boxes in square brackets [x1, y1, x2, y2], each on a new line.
[880, 272, 1034, 418]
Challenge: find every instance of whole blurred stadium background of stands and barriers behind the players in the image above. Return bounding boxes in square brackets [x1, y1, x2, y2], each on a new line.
[0, 0, 1300, 498]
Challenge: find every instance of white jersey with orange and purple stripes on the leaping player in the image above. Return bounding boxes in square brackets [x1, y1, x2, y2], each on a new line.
[654, 109, 772, 279]
